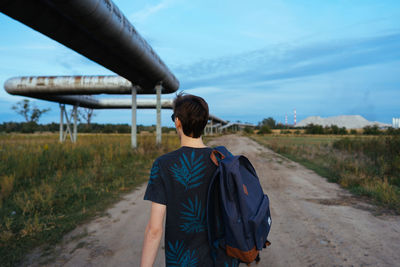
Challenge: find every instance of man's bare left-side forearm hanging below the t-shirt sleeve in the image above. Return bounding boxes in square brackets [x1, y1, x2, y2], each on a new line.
[140, 202, 166, 267]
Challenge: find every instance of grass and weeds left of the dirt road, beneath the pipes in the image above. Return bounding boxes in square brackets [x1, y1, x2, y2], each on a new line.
[0, 134, 179, 266]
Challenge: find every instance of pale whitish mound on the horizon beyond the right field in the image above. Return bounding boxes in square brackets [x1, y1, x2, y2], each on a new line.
[296, 115, 391, 129]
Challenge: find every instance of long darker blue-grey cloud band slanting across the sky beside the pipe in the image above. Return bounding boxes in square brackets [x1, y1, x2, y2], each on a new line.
[175, 32, 400, 89]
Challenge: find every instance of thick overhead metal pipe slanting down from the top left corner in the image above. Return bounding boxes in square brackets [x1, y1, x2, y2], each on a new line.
[0, 0, 179, 94]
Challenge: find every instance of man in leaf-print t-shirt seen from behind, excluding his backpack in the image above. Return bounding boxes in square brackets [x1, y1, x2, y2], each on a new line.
[141, 94, 238, 267]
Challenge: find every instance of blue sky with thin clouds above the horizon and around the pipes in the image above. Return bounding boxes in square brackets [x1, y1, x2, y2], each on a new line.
[0, 0, 400, 126]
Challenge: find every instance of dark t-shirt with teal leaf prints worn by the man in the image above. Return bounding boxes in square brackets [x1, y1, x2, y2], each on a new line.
[144, 146, 238, 267]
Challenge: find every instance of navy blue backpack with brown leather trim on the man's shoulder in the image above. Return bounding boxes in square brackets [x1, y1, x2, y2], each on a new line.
[207, 146, 271, 264]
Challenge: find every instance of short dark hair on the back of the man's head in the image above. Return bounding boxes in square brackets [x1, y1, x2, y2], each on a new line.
[173, 93, 208, 138]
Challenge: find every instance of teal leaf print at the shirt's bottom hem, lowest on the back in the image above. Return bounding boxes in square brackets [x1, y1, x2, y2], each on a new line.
[165, 241, 199, 267]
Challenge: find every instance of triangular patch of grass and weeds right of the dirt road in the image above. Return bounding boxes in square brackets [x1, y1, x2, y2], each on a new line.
[251, 135, 400, 214]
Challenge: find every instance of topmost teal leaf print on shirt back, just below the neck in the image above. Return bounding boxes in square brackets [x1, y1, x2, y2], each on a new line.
[171, 150, 205, 190]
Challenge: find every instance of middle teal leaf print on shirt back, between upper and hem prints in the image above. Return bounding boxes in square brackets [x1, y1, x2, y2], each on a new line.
[179, 196, 207, 233]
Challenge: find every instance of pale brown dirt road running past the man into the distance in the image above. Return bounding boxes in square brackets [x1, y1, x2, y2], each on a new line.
[28, 136, 400, 266]
